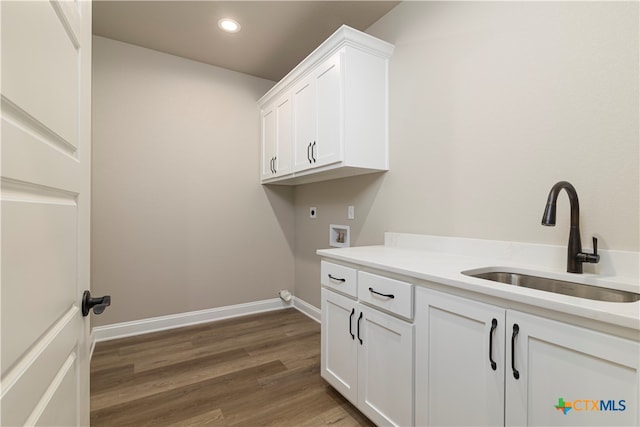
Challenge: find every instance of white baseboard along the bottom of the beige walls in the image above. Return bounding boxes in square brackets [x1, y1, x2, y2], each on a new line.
[91, 297, 320, 344]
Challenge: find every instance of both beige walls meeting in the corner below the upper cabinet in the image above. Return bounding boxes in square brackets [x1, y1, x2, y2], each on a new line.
[92, 2, 640, 325]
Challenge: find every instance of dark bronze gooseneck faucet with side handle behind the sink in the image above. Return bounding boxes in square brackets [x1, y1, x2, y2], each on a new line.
[542, 181, 600, 274]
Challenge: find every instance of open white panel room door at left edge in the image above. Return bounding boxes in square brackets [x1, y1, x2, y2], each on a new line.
[0, 0, 91, 426]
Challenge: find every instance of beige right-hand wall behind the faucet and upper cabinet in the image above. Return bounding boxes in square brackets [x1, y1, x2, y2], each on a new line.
[295, 2, 640, 307]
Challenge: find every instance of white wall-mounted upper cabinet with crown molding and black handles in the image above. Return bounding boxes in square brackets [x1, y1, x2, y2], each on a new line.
[258, 26, 393, 185]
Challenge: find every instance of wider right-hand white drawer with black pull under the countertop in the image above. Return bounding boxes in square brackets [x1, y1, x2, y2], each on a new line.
[358, 271, 413, 319]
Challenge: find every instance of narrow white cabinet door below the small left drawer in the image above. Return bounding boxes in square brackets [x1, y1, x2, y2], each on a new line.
[320, 288, 358, 405]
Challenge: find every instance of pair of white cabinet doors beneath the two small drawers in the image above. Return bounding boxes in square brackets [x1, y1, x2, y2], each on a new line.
[321, 288, 414, 426]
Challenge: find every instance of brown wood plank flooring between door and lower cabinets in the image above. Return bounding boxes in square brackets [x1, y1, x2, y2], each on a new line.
[91, 309, 373, 427]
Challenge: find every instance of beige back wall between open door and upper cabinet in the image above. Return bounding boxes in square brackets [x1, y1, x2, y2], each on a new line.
[91, 37, 294, 325]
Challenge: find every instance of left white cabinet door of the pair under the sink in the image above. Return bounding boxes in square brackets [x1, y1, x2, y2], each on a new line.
[415, 288, 505, 426]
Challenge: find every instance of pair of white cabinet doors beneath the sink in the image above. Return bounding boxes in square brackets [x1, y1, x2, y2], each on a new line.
[415, 288, 640, 426]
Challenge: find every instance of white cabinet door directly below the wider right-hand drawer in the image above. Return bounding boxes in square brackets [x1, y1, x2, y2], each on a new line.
[356, 304, 414, 426]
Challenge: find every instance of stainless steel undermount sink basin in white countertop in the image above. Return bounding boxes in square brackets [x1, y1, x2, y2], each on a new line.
[462, 271, 640, 302]
